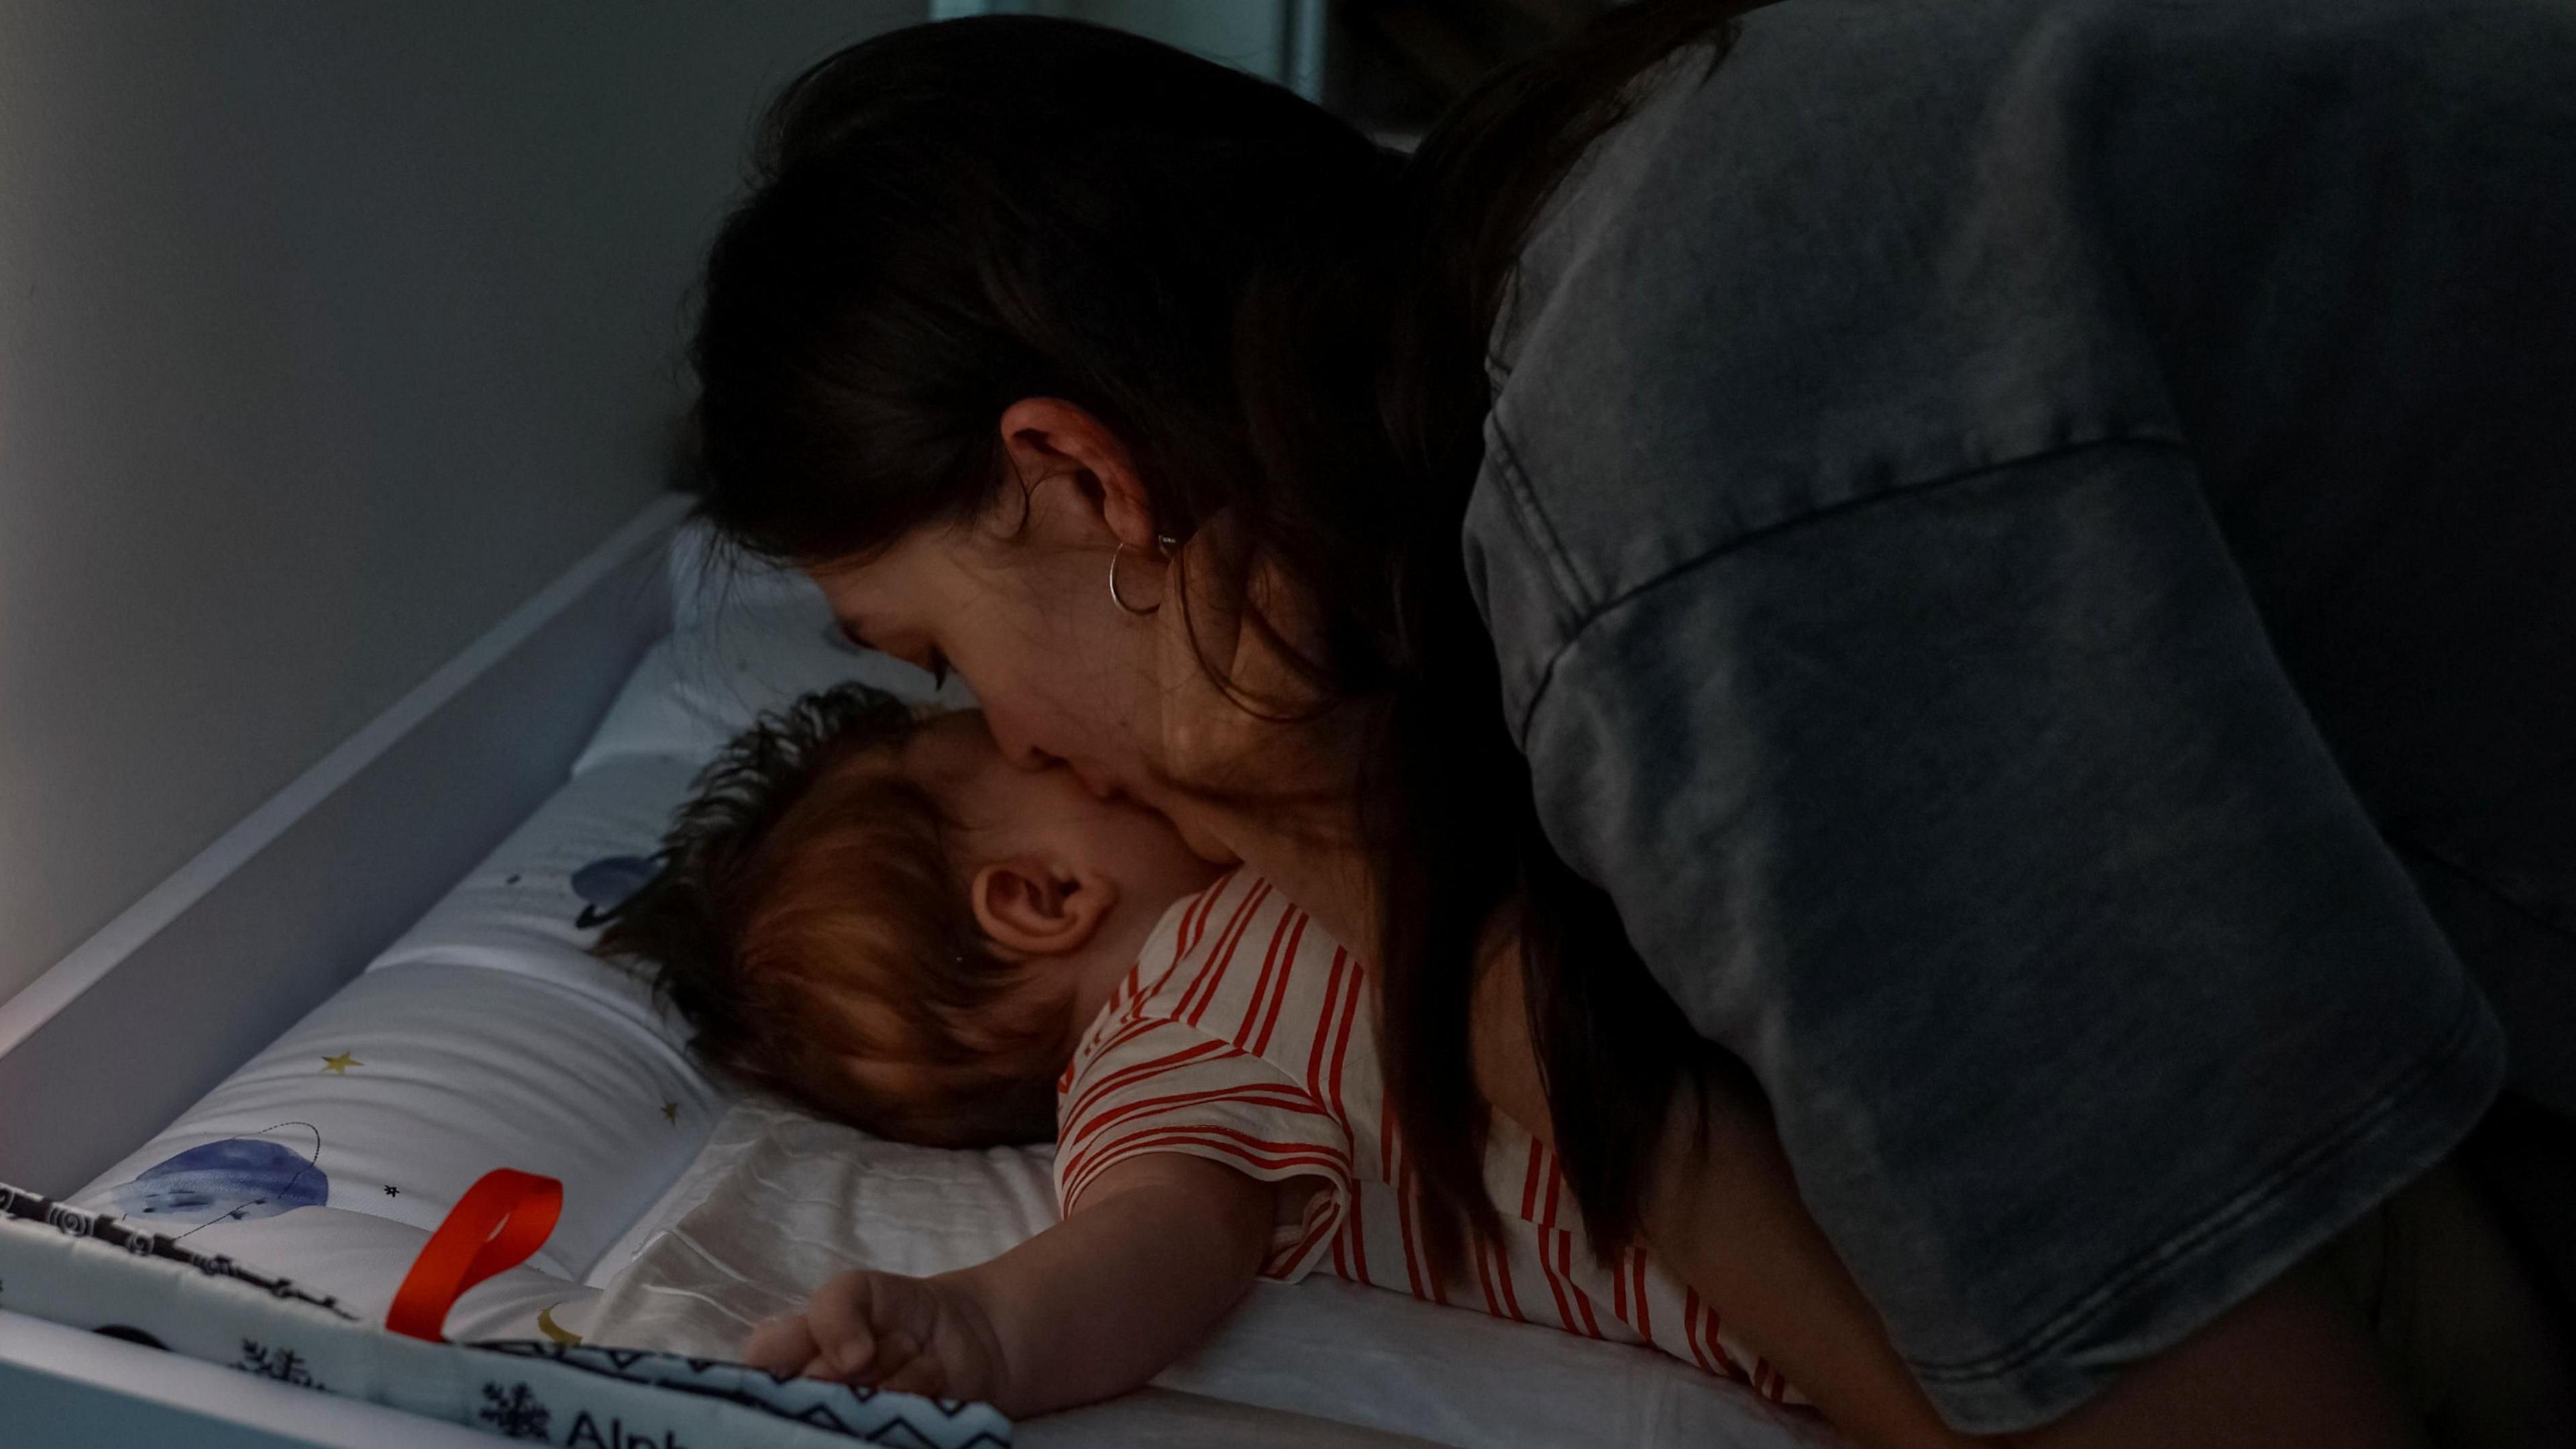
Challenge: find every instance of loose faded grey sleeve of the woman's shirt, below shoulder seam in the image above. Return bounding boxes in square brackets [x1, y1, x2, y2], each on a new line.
[1522, 443, 2502, 1428]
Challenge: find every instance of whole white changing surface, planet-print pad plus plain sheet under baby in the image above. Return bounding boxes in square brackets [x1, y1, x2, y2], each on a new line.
[74, 539, 1834, 1449]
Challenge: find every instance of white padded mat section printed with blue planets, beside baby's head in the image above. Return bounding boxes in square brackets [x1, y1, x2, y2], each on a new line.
[70, 529, 966, 1341]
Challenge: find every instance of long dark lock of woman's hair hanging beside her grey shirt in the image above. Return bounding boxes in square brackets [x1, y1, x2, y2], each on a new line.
[1362, 0, 1752, 1260]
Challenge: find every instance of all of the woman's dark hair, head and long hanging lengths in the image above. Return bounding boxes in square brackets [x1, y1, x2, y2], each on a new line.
[696, 0, 1744, 1263]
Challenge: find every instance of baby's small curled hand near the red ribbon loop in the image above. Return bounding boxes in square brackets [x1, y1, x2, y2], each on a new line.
[742, 1271, 1005, 1400]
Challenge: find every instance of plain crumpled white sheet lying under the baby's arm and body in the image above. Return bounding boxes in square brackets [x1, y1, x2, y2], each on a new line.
[590, 1098, 1839, 1449]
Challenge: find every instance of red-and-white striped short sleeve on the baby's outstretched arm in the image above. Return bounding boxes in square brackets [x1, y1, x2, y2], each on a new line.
[1056, 1016, 1355, 1281]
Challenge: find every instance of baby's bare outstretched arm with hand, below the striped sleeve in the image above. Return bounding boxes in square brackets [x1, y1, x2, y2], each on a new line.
[745, 1152, 1277, 1415]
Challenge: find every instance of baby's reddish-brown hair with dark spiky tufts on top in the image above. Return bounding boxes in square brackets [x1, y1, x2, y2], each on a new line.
[595, 684, 1069, 1147]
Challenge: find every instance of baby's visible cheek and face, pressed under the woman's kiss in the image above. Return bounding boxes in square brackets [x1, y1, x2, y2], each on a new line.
[904, 709, 1218, 913]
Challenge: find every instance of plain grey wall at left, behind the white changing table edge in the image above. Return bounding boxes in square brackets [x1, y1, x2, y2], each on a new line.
[0, 0, 927, 998]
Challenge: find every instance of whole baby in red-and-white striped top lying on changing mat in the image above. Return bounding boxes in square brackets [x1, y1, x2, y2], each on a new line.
[600, 686, 1795, 1415]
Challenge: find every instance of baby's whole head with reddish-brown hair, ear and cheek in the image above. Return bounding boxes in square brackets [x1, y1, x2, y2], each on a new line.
[598, 686, 1214, 1147]
